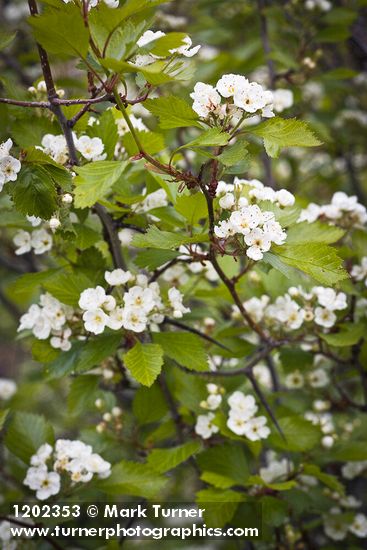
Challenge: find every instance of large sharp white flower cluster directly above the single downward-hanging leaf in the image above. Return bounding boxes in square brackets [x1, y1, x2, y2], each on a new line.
[79, 269, 190, 334]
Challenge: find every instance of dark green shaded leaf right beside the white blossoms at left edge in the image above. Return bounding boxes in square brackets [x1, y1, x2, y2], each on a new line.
[10, 166, 57, 220]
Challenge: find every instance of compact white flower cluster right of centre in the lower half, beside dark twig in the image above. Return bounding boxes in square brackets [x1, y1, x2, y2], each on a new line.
[227, 391, 270, 441]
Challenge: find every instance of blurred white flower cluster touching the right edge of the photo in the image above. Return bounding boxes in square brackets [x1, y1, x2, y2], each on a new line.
[298, 191, 367, 228]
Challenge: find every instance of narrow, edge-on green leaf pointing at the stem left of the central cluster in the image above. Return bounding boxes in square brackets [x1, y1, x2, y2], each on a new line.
[132, 225, 209, 249]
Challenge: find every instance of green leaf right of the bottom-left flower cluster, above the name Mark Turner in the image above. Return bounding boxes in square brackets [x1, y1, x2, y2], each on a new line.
[98, 460, 168, 499]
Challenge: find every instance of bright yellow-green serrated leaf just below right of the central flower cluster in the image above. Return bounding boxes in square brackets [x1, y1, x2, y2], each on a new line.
[272, 243, 348, 286]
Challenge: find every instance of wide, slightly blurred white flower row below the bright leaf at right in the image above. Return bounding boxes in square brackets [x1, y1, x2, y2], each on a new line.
[237, 286, 348, 331]
